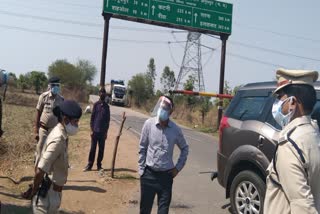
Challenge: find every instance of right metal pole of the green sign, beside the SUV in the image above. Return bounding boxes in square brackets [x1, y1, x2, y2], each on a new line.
[217, 34, 229, 128]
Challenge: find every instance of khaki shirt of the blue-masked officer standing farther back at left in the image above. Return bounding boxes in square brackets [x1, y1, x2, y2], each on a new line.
[37, 91, 63, 129]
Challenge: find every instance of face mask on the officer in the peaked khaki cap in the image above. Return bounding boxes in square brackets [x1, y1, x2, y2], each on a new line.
[272, 97, 295, 127]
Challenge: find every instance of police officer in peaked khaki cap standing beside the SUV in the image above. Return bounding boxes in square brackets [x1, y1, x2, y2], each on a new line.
[264, 69, 320, 214]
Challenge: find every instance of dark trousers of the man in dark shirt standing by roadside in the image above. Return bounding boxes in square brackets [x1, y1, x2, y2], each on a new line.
[88, 132, 106, 168]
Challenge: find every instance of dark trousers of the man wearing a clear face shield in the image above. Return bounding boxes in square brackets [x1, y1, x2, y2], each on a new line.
[140, 167, 173, 214]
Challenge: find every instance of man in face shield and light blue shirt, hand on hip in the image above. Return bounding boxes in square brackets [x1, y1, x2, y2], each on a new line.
[138, 96, 189, 214]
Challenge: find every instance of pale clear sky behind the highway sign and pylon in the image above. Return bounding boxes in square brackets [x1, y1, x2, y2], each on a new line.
[0, 0, 320, 92]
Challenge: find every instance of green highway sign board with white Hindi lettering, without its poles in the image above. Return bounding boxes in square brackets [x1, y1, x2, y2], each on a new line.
[103, 0, 232, 34]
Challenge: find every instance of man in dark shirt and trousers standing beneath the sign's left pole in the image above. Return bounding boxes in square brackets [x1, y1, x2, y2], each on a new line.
[83, 87, 110, 171]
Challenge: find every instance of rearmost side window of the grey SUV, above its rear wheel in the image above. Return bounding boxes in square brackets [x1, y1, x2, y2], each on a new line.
[230, 97, 268, 121]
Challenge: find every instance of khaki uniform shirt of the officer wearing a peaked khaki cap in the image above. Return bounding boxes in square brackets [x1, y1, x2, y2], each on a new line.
[264, 116, 320, 214]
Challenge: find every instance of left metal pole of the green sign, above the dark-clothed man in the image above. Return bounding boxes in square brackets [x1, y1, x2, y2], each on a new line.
[100, 13, 112, 87]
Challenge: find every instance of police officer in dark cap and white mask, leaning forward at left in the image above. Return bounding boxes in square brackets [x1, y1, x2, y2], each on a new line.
[31, 100, 82, 213]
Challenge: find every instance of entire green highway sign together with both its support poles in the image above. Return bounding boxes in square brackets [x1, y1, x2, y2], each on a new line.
[100, 0, 233, 127]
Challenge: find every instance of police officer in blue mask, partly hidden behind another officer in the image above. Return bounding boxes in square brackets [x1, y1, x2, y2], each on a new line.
[35, 77, 63, 165]
